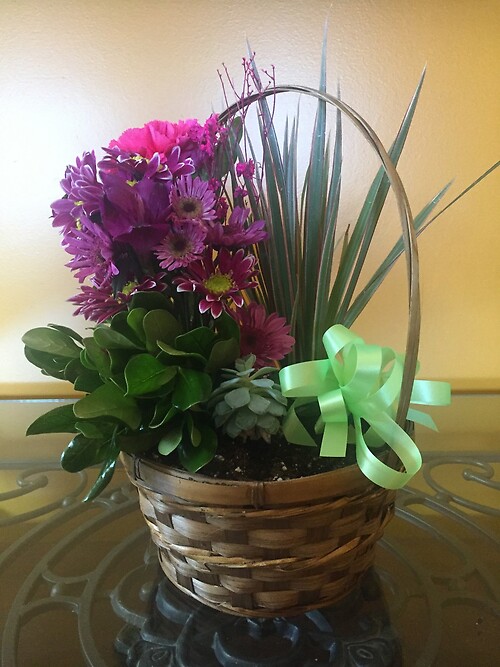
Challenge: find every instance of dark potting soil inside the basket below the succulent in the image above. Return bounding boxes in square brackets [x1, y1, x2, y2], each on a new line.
[152, 439, 355, 481]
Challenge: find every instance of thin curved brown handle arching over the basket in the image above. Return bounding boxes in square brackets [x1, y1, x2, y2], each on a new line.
[219, 84, 420, 427]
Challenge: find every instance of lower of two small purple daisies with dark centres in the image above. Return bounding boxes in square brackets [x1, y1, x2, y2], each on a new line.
[156, 222, 207, 271]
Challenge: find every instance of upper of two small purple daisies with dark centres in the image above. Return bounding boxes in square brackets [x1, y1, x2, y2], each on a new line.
[170, 176, 215, 222]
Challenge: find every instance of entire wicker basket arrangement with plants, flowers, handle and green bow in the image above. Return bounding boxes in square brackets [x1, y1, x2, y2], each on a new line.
[23, 58, 488, 616]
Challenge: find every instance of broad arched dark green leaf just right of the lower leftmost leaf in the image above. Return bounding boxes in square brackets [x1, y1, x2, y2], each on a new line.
[74, 384, 141, 430]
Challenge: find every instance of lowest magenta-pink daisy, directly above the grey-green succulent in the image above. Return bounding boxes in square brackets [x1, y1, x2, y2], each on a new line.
[235, 303, 295, 368]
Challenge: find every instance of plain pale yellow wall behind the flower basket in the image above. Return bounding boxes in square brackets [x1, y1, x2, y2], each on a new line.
[0, 0, 500, 396]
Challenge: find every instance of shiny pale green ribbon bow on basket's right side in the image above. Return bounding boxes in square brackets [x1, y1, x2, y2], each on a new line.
[279, 324, 450, 489]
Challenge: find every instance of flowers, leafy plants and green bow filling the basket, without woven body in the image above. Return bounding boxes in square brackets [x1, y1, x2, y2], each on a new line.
[23, 58, 488, 499]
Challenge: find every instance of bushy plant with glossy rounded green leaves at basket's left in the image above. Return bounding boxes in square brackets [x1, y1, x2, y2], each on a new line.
[23, 293, 239, 500]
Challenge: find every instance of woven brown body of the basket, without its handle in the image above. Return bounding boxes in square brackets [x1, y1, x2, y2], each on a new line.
[122, 454, 395, 616]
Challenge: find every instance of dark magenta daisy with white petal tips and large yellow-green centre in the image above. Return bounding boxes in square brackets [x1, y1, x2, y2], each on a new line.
[174, 248, 257, 317]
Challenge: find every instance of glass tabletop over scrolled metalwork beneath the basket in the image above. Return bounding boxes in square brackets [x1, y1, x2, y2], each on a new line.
[0, 396, 500, 667]
